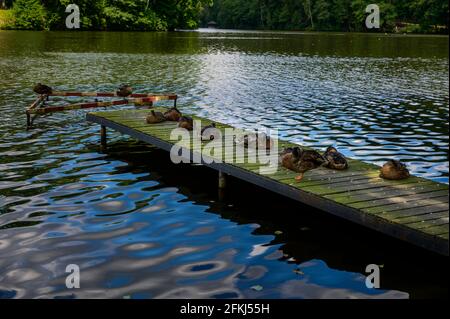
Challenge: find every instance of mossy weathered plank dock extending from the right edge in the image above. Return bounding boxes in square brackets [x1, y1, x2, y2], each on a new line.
[86, 108, 449, 256]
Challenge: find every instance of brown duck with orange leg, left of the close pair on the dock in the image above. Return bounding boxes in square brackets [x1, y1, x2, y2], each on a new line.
[279, 147, 326, 182]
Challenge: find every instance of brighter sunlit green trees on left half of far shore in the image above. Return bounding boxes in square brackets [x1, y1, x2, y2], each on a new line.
[7, 0, 212, 31]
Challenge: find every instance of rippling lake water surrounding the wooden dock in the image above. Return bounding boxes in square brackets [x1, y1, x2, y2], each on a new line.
[0, 30, 449, 298]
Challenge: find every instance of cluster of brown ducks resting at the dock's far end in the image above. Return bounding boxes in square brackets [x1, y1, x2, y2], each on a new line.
[146, 106, 216, 141]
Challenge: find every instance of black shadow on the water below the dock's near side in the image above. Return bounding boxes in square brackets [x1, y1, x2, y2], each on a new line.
[104, 142, 448, 298]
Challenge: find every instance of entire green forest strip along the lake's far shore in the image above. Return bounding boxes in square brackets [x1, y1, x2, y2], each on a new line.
[0, 0, 449, 34]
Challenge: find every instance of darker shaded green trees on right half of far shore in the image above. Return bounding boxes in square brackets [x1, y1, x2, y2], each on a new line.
[206, 0, 448, 32]
